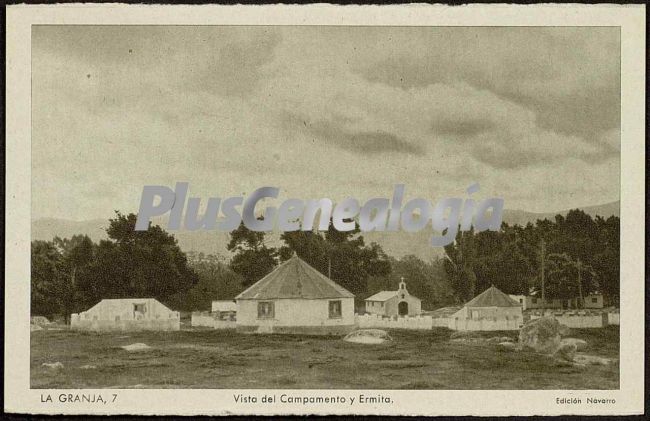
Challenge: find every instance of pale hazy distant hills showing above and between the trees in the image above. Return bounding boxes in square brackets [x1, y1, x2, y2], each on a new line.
[32, 202, 620, 260]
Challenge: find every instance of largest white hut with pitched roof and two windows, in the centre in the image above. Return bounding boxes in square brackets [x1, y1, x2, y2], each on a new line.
[235, 254, 355, 334]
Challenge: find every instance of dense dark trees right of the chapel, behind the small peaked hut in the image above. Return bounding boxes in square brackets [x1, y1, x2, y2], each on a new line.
[444, 209, 620, 305]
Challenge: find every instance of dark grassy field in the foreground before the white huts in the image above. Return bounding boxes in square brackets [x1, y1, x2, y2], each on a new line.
[31, 326, 619, 389]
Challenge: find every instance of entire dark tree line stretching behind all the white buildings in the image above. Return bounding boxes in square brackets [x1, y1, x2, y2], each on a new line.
[31, 210, 619, 319]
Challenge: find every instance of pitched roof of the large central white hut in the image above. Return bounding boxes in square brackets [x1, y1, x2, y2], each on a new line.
[235, 255, 354, 300]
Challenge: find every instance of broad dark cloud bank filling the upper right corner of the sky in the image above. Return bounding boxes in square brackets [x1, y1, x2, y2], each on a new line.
[351, 28, 620, 145]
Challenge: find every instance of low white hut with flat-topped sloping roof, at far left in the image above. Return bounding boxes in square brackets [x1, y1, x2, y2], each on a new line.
[70, 298, 180, 331]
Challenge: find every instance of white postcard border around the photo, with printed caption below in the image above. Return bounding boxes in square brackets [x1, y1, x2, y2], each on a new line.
[4, 4, 645, 416]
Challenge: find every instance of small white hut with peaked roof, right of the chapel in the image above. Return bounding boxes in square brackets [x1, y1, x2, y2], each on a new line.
[449, 285, 523, 330]
